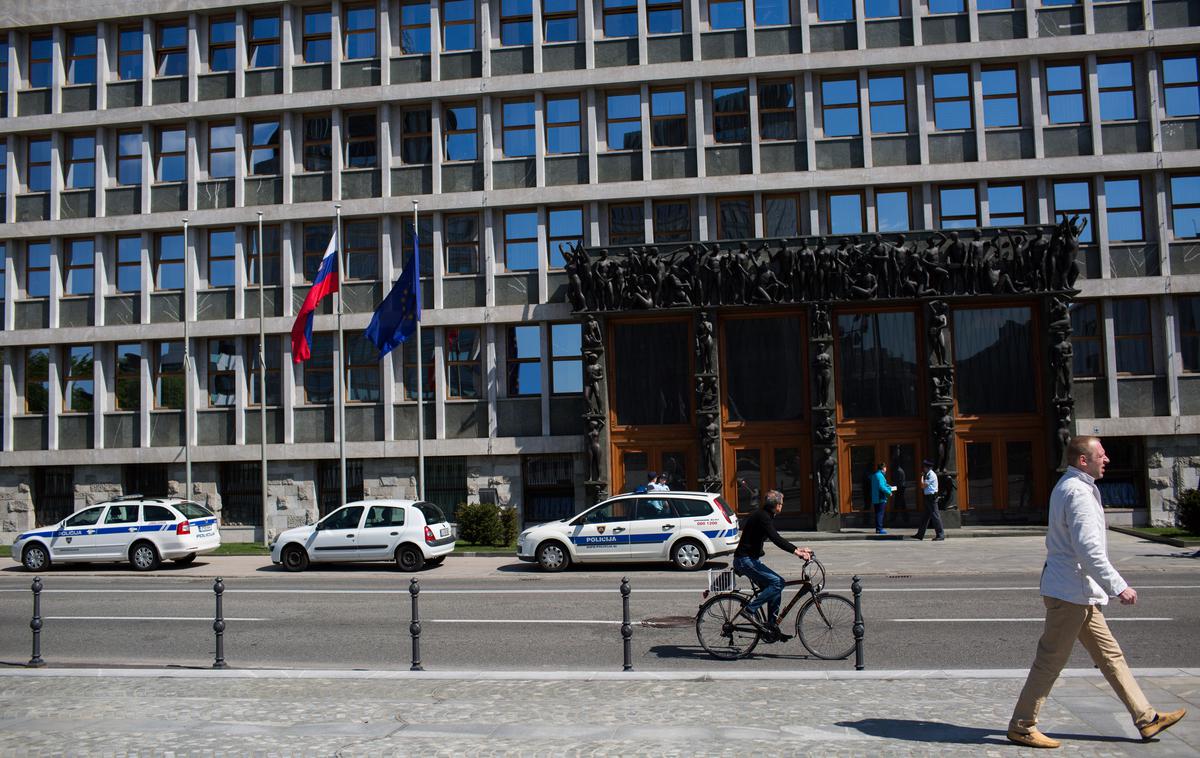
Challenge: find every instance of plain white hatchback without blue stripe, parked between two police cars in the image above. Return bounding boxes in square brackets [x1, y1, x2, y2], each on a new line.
[271, 500, 455, 571]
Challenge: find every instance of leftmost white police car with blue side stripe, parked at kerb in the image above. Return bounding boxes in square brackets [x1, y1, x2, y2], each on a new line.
[12, 495, 221, 571]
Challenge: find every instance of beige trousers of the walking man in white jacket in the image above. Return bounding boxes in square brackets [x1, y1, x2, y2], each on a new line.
[1008, 597, 1154, 734]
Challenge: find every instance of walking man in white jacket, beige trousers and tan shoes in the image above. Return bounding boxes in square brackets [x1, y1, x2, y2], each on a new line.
[1008, 437, 1187, 747]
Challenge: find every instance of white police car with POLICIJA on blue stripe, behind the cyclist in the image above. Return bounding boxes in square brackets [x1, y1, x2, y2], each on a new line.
[517, 492, 740, 571]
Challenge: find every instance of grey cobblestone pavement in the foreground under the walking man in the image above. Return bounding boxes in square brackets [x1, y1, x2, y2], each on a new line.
[0, 669, 1200, 756]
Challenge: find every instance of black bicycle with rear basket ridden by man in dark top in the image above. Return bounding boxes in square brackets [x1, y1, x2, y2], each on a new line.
[696, 557, 854, 661]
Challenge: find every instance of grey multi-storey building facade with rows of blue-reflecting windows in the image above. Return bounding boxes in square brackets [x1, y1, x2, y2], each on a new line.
[0, 0, 1200, 540]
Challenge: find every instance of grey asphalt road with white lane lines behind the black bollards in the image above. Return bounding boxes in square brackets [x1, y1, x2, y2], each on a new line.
[0, 566, 1200, 670]
